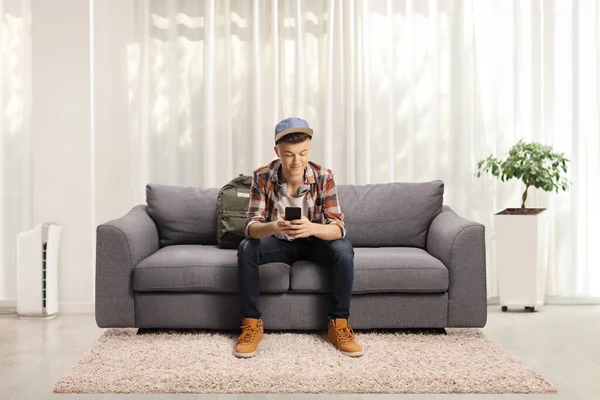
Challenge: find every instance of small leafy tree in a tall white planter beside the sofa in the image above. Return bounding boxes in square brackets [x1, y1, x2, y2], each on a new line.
[475, 139, 570, 312]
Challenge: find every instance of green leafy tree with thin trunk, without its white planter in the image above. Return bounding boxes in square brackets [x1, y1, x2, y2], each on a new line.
[475, 139, 570, 208]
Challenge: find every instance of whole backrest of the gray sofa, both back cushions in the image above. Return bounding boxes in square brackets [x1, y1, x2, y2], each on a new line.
[146, 180, 444, 248]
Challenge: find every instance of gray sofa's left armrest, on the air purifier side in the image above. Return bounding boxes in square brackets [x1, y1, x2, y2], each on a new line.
[95, 205, 160, 328]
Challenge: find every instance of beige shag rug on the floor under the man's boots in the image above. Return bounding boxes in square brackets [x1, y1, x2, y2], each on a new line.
[54, 329, 556, 393]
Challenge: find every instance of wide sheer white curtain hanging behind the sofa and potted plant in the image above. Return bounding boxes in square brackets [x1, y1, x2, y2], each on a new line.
[94, 0, 600, 301]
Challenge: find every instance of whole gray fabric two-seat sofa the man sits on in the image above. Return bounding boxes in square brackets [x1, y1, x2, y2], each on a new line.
[95, 180, 487, 330]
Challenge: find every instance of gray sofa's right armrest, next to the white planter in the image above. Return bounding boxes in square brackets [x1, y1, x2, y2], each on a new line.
[427, 206, 487, 327]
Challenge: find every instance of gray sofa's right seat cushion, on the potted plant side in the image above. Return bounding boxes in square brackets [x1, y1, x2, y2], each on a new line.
[291, 247, 448, 293]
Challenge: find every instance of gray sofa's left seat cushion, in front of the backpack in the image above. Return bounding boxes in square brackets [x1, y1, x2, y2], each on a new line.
[133, 245, 290, 293]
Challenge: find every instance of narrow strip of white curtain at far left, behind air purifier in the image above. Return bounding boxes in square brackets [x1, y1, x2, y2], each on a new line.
[0, 0, 32, 311]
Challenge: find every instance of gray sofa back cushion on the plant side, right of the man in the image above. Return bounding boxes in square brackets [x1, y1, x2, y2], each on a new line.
[337, 180, 444, 249]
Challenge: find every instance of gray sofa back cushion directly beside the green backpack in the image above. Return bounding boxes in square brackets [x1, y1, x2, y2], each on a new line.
[146, 183, 219, 247]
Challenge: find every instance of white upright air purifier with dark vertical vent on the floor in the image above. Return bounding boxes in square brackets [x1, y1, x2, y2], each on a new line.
[17, 223, 62, 319]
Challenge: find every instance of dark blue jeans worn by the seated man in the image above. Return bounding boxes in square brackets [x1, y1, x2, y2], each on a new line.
[237, 236, 354, 319]
